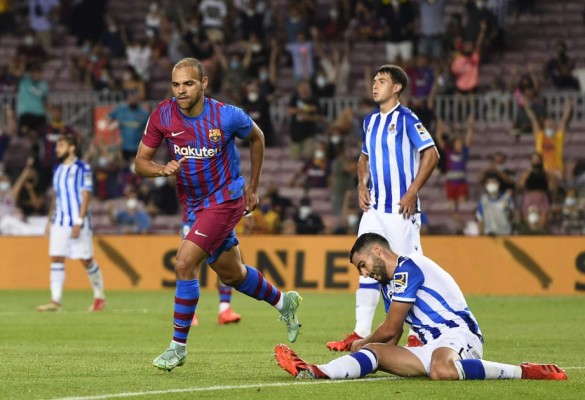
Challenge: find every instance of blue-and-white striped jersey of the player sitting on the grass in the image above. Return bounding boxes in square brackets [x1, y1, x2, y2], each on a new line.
[382, 254, 482, 344]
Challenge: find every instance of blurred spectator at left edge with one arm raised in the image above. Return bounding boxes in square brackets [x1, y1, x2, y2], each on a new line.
[0, 158, 34, 235]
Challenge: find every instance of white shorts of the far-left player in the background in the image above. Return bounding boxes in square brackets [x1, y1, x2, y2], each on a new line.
[49, 225, 93, 260]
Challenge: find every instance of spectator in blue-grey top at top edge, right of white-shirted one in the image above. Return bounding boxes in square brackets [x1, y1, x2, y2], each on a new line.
[417, 0, 447, 60]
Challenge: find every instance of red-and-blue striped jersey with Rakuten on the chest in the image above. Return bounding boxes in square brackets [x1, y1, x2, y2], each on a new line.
[142, 97, 253, 220]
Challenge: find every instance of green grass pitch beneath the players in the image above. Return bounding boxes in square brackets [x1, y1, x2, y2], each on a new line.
[0, 291, 585, 400]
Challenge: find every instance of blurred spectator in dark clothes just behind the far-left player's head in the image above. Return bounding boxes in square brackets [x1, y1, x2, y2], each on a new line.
[36, 104, 79, 190]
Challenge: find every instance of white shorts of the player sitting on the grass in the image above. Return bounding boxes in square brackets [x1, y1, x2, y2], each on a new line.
[405, 329, 483, 375]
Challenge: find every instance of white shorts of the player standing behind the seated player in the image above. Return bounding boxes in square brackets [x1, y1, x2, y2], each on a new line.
[358, 208, 422, 255]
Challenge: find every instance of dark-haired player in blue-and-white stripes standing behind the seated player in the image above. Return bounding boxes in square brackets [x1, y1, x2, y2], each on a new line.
[327, 65, 439, 351]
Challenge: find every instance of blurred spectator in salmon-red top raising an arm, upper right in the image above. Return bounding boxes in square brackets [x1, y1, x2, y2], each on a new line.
[451, 22, 487, 94]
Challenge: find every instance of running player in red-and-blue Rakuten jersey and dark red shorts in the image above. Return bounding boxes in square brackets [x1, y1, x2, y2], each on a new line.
[135, 58, 302, 371]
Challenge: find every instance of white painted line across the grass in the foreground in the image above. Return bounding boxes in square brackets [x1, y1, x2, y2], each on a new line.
[53, 376, 402, 400]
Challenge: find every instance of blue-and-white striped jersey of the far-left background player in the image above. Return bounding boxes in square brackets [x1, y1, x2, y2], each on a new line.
[52, 159, 93, 226]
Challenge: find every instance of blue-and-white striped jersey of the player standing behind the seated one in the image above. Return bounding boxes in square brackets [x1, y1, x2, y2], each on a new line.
[362, 103, 435, 213]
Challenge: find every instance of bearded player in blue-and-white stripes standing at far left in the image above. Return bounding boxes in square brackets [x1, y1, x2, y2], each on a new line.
[37, 134, 106, 311]
